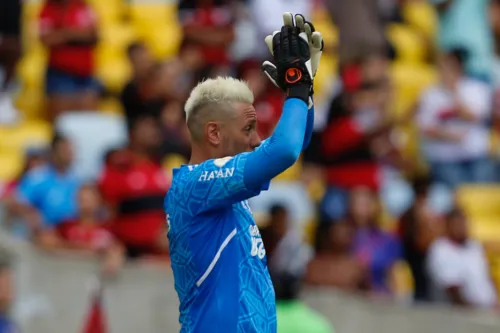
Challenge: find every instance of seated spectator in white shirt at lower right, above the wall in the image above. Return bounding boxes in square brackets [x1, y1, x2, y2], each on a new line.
[427, 208, 497, 308]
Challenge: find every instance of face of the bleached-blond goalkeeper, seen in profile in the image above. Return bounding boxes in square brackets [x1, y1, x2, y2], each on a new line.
[220, 103, 261, 156]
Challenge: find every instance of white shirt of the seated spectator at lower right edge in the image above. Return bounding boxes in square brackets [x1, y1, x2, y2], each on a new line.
[427, 238, 497, 307]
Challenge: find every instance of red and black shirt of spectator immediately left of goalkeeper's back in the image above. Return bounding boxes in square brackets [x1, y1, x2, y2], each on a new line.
[99, 151, 170, 248]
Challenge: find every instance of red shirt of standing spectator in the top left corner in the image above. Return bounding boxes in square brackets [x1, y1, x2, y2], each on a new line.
[40, 0, 96, 76]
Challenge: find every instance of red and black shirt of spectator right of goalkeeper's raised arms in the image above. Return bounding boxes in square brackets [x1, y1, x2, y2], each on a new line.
[322, 116, 380, 190]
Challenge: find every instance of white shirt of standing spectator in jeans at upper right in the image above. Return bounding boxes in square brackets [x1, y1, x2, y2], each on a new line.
[417, 79, 492, 162]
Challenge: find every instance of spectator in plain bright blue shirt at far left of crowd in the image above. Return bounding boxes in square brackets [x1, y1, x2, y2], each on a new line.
[15, 133, 81, 228]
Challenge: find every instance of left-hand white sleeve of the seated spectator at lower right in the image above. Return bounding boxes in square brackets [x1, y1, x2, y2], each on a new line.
[428, 242, 463, 288]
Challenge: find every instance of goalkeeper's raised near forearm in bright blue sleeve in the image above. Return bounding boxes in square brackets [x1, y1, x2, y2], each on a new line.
[244, 98, 308, 188]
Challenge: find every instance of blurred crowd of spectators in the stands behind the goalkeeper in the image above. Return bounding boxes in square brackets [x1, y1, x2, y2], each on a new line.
[0, 0, 500, 332]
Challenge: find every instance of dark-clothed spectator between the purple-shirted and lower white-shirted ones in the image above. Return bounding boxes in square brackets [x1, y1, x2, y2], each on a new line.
[399, 178, 441, 302]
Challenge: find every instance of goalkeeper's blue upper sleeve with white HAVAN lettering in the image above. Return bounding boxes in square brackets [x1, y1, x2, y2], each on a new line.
[183, 153, 269, 213]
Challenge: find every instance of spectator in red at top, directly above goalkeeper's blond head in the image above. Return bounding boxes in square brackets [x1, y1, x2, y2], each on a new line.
[179, 0, 235, 72]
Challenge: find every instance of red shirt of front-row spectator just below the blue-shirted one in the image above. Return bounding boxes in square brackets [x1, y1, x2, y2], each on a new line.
[57, 221, 114, 250]
